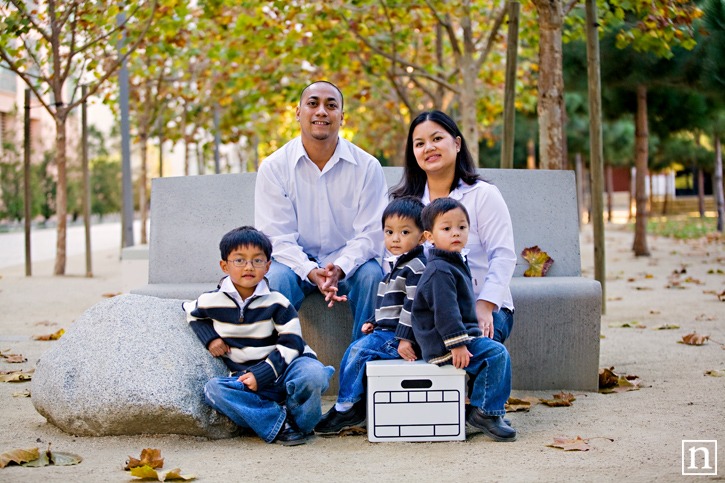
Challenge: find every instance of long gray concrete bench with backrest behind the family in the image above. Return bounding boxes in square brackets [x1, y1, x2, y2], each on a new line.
[132, 168, 601, 392]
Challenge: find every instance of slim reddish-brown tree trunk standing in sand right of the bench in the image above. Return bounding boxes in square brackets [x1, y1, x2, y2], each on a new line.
[633, 85, 650, 257]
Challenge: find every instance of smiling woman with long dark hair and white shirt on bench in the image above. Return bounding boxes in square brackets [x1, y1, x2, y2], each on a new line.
[391, 111, 516, 343]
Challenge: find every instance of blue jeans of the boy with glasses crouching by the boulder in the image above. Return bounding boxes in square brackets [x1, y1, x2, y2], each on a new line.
[204, 356, 335, 443]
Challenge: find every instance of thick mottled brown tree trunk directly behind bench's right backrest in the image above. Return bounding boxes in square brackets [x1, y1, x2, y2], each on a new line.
[534, 0, 566, 169]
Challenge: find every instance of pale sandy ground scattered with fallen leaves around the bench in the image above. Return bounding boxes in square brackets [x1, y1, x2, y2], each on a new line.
[0, 225, 725, 482]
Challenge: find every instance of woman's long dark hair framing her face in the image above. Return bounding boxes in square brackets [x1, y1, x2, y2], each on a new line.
[390, 111, 481, 199]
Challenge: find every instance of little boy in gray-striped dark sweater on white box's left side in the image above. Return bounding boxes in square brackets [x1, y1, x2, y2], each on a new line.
[315, 196, 425, 435]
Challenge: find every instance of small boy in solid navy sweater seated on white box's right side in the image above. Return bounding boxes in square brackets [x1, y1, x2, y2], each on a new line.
[412, 198, 516, 441]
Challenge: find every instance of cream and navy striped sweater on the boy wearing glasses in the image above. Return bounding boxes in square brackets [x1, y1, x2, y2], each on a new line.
[183, 289, 316, 388]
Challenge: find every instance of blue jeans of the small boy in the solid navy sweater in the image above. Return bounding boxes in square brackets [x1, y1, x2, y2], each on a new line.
[465, 337, 511, 416]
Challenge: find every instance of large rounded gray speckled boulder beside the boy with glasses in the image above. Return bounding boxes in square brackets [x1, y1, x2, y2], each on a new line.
[31, 295, 237, 438]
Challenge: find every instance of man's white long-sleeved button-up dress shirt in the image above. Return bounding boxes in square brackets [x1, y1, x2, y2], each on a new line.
[254, 137, 388, 280]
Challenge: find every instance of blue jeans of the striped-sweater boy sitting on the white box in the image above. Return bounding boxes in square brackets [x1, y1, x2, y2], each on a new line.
[337, 330, 400, 403]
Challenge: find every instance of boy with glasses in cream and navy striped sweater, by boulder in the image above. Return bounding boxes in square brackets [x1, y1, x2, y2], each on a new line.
[183, 226, 334, 446]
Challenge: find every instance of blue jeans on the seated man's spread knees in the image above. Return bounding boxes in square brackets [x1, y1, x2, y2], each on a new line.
[267, 260, 383, 342]
